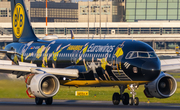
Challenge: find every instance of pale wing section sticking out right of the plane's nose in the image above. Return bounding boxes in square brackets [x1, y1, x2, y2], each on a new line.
[161, 58, 180, 71]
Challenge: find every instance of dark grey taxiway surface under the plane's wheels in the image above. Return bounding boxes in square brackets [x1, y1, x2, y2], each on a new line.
[0, 99, 180, 110]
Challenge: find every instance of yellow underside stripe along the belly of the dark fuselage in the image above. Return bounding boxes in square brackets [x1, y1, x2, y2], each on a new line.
[60, 80, 149, 87]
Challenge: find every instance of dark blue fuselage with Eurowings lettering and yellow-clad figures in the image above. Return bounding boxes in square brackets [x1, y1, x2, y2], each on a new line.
[5, 39, 160, 85]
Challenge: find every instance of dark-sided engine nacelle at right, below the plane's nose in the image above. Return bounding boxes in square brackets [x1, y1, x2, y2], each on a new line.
[144, 72, 177, 98]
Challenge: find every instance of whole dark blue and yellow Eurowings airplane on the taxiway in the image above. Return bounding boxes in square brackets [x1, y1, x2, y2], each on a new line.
[0, 0, 177, 105]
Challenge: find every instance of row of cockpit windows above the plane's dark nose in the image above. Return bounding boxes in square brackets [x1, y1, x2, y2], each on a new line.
[126, 51, 157, 59]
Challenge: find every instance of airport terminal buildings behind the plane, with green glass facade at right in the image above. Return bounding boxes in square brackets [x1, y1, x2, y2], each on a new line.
[0, 0, 180, 54]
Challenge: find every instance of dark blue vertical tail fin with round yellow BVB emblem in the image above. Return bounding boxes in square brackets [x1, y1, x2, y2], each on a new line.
[11, 0, 38, 42]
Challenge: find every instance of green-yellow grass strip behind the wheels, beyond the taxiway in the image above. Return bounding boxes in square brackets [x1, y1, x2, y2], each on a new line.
[0, 80, 180, 103]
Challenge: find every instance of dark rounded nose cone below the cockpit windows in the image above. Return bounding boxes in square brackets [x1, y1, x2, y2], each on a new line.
[141, 59, 161, 81]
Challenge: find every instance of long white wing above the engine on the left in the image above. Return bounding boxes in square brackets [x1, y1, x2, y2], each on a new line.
[0, 60, 79, 78]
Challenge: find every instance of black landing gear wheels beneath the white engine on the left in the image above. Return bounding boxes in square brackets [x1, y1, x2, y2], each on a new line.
[35, 97, 53, 105]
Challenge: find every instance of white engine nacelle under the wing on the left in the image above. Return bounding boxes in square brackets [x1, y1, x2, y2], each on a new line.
[27, 73, 60, 98]
